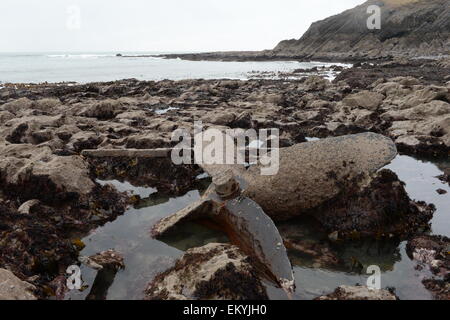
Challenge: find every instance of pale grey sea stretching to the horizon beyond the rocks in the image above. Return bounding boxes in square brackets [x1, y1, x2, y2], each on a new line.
[0, 52, 349, 87]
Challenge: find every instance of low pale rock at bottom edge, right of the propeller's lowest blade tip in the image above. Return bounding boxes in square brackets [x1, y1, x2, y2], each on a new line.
[315, 286, 398, 300]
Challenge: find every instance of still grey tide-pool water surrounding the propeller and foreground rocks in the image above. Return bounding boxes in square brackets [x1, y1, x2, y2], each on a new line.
[67, 155, 450, 300]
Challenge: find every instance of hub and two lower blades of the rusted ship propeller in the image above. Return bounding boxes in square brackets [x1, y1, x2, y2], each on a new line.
[152, 170, 295, 297]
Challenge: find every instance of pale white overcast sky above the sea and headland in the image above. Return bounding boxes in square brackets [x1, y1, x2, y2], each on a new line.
[0, 0, 364, 52]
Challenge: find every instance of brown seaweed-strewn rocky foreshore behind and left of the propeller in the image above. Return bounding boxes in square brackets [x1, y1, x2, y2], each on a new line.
[0, 56, 450, 298]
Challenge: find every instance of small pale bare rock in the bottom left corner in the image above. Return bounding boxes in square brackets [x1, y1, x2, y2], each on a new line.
[0, 269, 37, 300]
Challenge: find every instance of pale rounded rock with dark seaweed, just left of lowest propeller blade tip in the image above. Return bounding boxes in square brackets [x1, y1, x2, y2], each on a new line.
[146, 244, 268, 300]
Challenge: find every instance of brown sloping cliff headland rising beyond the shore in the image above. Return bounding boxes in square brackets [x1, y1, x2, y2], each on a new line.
[272, 0, 450, 60]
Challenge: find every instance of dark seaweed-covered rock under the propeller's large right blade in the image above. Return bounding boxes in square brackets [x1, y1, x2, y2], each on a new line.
[309, 169, 435, 238]
